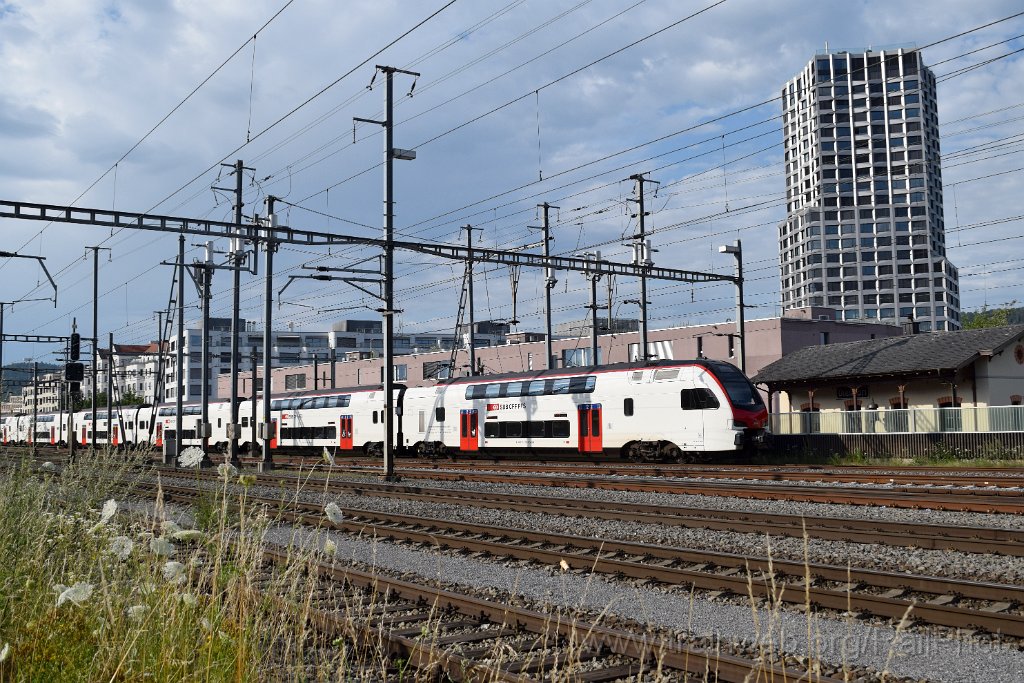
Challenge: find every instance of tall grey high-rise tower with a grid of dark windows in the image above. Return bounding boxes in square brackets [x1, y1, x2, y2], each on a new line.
[778, 49, 961, 332]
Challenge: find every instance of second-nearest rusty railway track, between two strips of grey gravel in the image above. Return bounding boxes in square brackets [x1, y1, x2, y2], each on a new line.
[149, 484, 1024, 638]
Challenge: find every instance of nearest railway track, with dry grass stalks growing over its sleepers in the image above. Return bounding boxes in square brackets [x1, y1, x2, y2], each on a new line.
[135, 482, 831, 683]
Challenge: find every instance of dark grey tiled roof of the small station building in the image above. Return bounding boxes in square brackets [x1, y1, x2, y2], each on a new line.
[753, 325, 1024, 384]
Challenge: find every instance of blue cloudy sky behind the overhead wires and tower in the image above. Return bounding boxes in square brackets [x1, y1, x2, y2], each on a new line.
[0, 0, 1024, 362]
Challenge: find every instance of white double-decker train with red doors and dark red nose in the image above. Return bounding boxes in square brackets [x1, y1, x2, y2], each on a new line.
[0, 359, 769, 462]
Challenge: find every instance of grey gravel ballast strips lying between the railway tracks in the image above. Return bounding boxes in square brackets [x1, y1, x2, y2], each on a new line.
[151, 475, 1024, 681]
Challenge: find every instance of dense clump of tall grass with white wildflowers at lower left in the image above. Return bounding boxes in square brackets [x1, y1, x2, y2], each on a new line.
[0, 453, 385, 682]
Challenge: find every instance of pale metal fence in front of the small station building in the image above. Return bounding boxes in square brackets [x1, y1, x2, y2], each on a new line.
[771, 405, 1024, 458]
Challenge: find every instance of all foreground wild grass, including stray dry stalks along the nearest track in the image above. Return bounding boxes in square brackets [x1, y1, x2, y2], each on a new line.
[0, 446, 921, 683]
